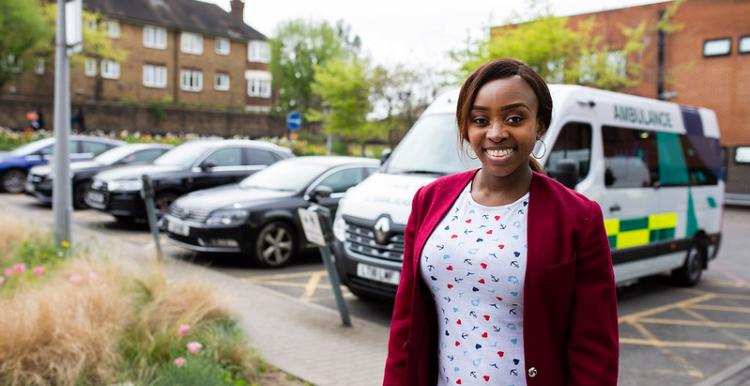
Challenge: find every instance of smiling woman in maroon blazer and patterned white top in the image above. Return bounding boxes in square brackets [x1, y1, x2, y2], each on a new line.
[384, 59, 619, 386]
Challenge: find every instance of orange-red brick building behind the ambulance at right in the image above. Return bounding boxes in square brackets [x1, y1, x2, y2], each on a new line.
[493, 0, 750, 202]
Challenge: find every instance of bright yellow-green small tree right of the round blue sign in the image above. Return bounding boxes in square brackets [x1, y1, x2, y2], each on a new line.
[307, 58, 382, 153]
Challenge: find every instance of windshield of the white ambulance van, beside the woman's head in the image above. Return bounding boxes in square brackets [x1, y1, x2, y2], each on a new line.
[385, 114, 480, 175]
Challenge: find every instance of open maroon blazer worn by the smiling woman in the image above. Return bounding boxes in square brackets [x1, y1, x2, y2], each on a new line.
[383, 170, 619, 386]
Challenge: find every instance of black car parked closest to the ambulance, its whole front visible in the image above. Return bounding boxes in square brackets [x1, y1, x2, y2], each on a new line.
[164, 156, 379, 267]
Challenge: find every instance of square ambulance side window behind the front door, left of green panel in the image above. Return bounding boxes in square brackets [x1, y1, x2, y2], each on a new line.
[602, 126, 659, 188]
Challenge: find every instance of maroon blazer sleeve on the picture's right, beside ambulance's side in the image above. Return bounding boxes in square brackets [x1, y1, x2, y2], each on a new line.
[566, 201, 619, 386]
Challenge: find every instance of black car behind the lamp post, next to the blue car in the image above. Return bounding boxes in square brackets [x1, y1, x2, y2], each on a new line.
[26, 144, 172, 209]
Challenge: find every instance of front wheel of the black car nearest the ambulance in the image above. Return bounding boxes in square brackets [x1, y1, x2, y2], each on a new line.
[253, 221, 297, 267]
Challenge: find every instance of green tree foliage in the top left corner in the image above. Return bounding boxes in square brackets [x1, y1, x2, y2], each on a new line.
[0, 0, 52, 87]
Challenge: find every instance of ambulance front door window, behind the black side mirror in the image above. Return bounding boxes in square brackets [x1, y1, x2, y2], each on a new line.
[546, 122, 591, 182]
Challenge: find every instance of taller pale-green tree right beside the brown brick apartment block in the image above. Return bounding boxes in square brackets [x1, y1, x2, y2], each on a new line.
[271, 20, 360, 113]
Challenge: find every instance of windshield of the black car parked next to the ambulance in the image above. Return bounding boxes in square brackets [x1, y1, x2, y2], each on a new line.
[240, 158, 328, 192]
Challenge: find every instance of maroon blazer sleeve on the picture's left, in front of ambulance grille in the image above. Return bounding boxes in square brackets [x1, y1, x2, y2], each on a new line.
[383, 188, 422, 386]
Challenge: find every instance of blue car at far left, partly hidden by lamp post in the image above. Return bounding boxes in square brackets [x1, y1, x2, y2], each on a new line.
[0, 135, 125, 193]
